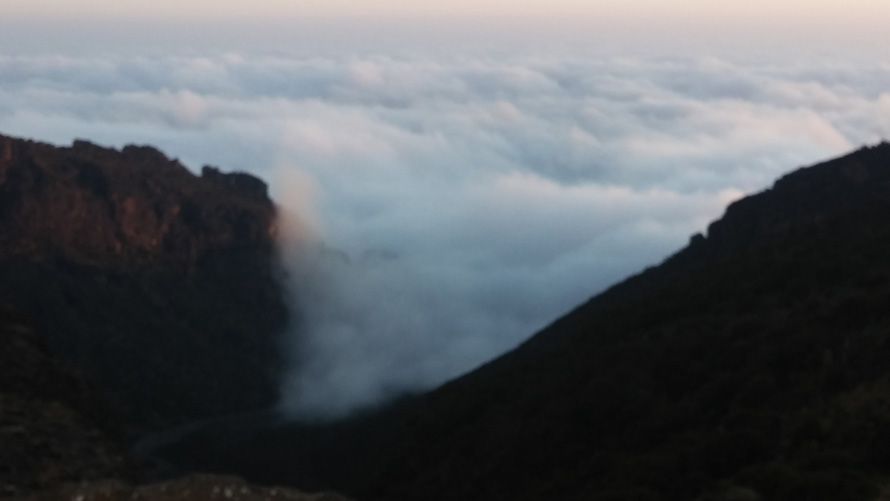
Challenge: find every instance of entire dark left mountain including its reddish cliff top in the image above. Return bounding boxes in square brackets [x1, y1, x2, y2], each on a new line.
[0, 136, 286, 433]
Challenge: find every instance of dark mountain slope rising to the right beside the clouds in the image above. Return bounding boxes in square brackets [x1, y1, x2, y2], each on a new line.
[366, 144, 890, 500]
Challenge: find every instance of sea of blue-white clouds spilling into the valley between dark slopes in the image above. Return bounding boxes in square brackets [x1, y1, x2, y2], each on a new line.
[0, 53, 890, 415]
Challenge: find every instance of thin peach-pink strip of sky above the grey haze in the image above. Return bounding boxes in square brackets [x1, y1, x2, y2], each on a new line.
[4, 0, 890, 24]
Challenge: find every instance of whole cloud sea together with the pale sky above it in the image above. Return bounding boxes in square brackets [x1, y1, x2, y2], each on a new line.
[0, 0, 890, 418]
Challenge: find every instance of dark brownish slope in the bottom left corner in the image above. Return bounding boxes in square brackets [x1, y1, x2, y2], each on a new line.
[0, 305, 133, 497]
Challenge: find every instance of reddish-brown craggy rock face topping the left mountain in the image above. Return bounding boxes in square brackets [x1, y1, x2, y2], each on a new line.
[0, 137, 275, 269]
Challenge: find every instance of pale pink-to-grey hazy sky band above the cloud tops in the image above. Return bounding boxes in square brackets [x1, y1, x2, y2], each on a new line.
[0, 0, 890, 61]
